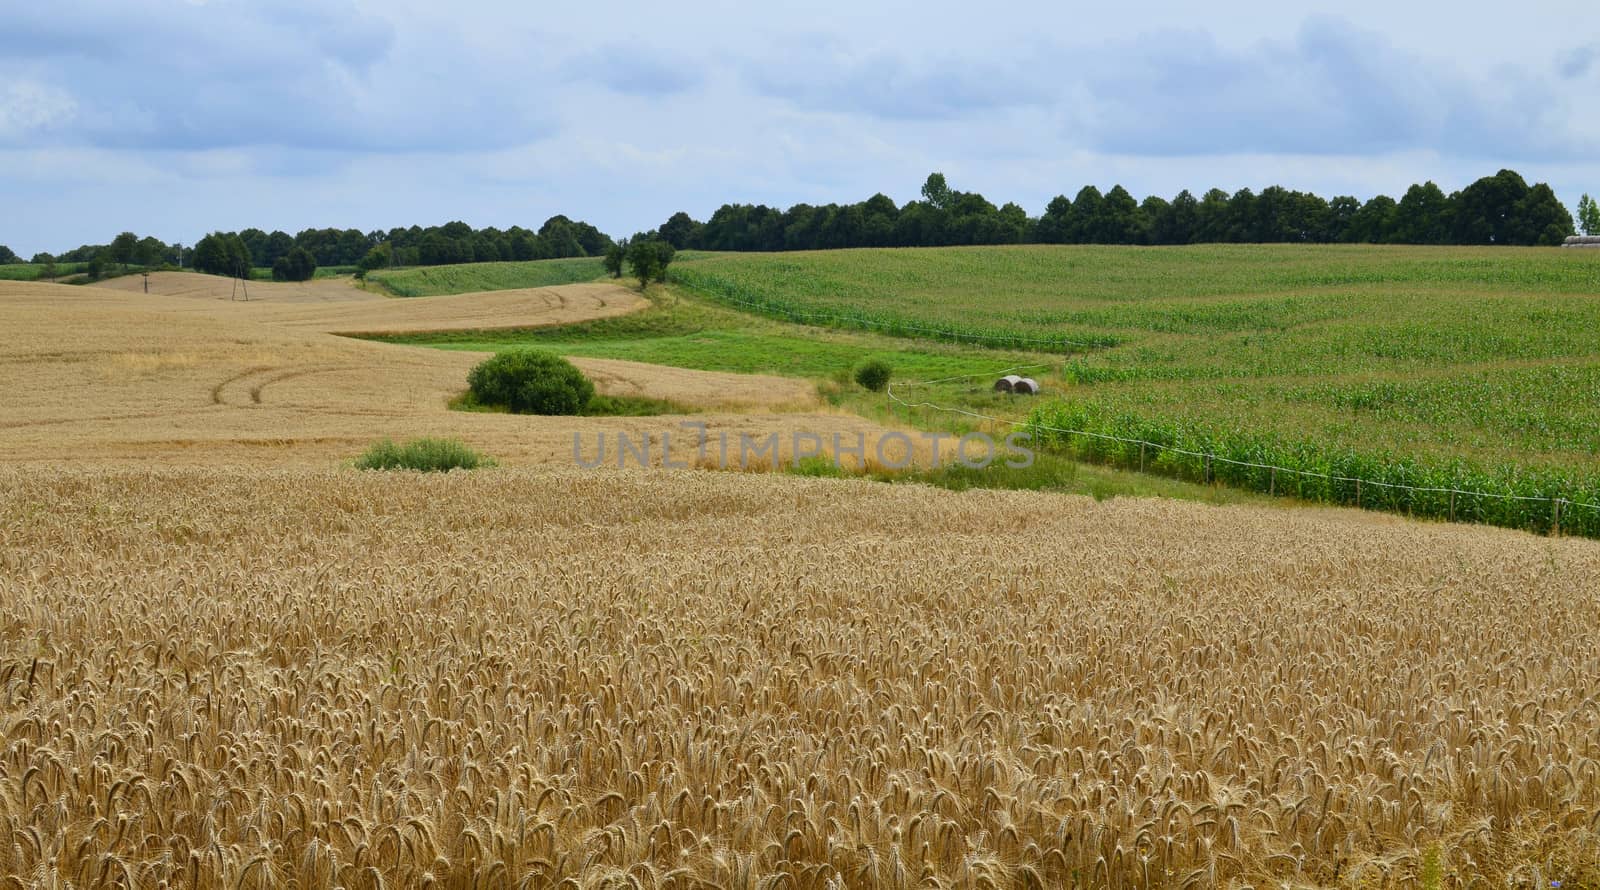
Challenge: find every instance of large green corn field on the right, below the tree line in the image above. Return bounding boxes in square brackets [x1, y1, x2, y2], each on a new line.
[674, 245, 1600, 530]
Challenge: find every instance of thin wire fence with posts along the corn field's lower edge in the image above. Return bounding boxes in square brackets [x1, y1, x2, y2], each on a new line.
[885, 363, 1600, 536]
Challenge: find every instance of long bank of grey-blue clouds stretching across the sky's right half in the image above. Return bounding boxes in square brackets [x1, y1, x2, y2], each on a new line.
[739, 18, 1597, 160]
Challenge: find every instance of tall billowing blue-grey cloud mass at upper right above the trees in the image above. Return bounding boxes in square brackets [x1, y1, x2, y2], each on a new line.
[1074, 19, 1590, 158]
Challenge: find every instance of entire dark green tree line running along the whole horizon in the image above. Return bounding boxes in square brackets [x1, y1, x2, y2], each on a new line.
[0, 170, 1600, 280]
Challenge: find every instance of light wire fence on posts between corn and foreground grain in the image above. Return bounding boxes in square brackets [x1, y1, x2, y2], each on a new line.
[886, 363, 1600, 536]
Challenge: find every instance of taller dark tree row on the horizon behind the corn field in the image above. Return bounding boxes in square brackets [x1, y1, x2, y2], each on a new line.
[642, 170, 1580, 251]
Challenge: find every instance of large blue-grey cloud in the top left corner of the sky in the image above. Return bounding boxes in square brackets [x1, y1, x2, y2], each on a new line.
[0, 0, 550, 154]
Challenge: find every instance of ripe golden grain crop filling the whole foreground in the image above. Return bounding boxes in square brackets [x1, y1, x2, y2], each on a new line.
[0, 469, 1600, 890]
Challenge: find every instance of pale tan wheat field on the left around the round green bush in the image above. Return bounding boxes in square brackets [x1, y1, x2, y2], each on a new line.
[0, 281, 885, 466]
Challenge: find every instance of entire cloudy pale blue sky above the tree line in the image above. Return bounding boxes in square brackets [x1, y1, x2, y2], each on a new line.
[0, 0, 1600, 256]
